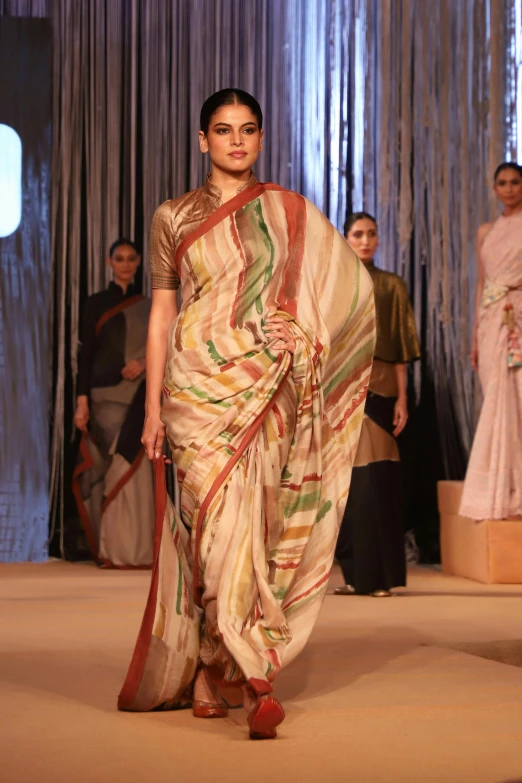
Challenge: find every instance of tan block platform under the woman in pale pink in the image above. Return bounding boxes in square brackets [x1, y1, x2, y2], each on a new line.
[437, 481, 522, 584]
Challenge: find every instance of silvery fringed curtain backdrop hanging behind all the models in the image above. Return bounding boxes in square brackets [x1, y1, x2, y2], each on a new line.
[0, 0, 522, 548]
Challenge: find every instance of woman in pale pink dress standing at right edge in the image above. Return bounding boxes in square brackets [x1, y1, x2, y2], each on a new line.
[460, 163, 522, 520]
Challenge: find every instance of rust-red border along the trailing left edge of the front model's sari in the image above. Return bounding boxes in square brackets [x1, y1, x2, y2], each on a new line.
[118, 458, 167, 710]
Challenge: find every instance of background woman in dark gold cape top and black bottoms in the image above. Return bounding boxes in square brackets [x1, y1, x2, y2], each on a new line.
[335, 212, 420, 596]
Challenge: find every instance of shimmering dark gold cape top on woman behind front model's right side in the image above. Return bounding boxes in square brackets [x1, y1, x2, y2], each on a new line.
[366, 262, 421, 364]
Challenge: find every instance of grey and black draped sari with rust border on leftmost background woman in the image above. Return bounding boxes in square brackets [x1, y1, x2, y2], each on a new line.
[73, 296, 154, 568]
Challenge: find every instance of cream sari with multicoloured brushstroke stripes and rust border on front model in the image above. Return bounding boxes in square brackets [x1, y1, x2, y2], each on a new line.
[118, 184, 375, 710]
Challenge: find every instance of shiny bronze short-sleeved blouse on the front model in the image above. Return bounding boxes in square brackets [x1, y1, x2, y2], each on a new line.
[150, 174, 257, 290]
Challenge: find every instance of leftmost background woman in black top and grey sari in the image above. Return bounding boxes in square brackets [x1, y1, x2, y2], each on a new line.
[73, 239, 154, 568]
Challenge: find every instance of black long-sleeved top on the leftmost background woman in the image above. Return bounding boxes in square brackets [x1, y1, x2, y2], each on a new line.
[76, 282, 136, 396]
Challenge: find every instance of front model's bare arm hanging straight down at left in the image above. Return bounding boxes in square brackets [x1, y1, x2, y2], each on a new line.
[141, 289, 178, 459]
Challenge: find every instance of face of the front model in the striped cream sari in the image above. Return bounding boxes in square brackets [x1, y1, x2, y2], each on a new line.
[199, 104, 263, 174]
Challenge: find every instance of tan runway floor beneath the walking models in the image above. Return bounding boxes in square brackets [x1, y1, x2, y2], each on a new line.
[0, 562, 522, 783]
